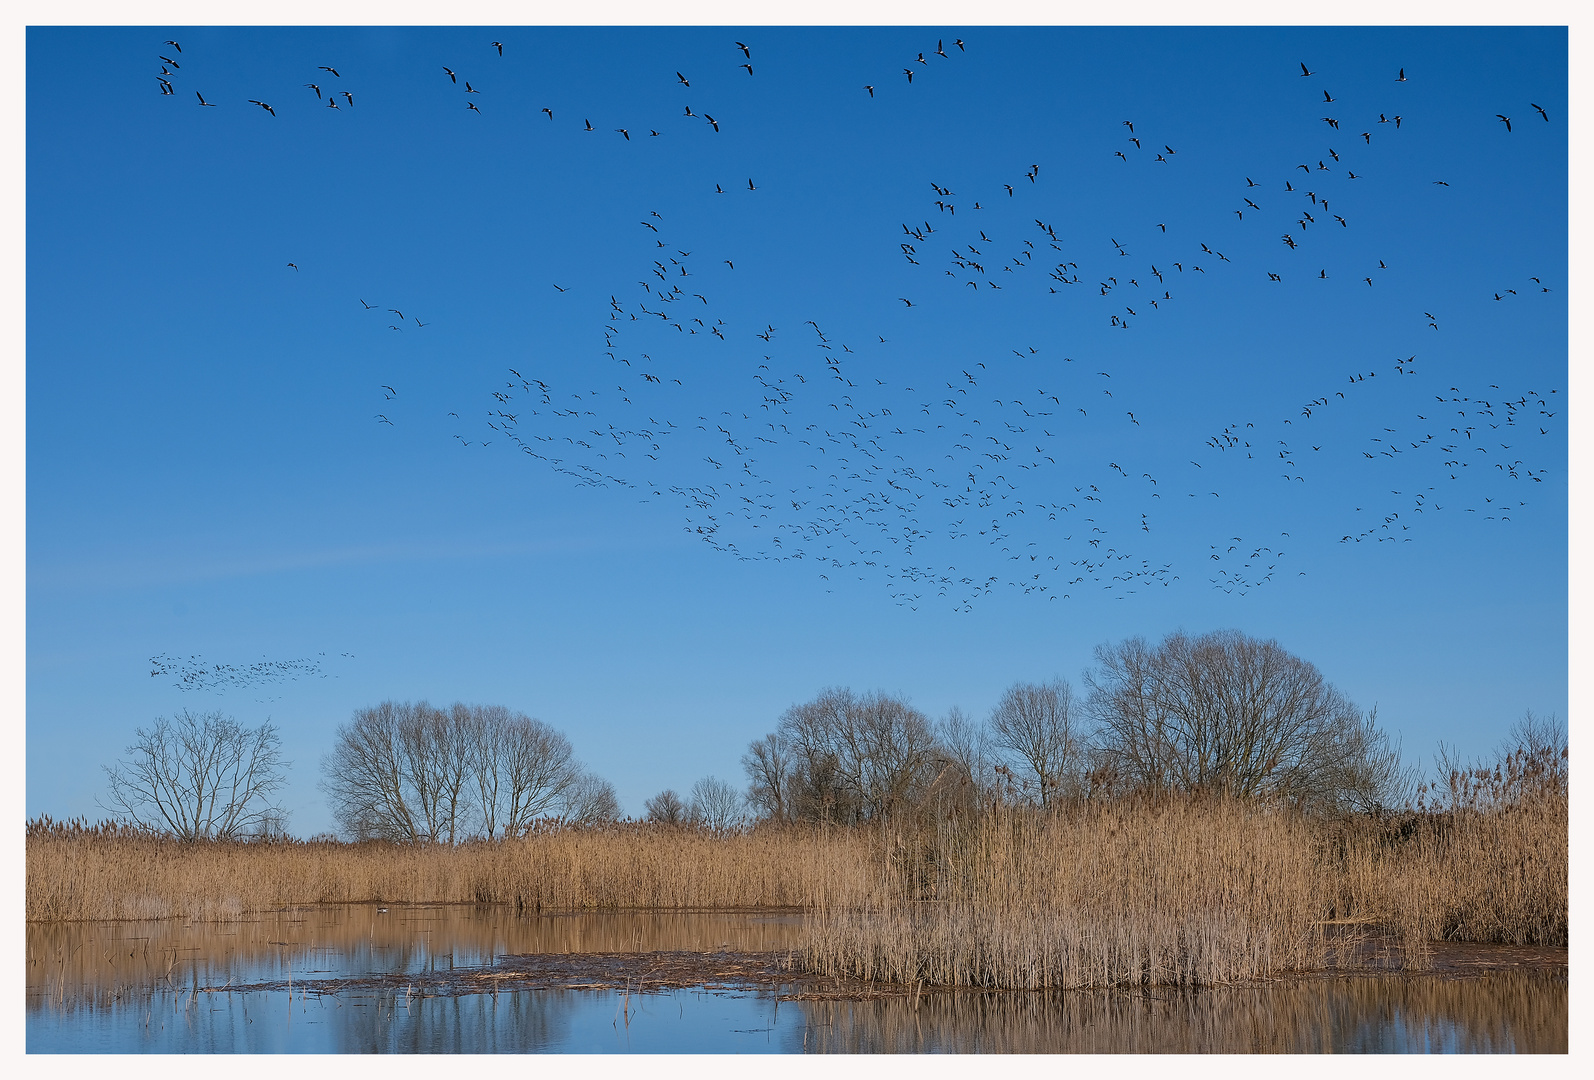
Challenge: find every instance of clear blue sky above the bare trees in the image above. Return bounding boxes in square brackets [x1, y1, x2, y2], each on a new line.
[27, 16, 1568, 835]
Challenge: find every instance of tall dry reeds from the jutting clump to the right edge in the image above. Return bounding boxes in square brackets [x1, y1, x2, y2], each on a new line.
[807, 796, 1568, 989]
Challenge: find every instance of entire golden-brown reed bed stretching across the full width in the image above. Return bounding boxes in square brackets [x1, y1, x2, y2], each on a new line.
[27, 795, 1568, 989]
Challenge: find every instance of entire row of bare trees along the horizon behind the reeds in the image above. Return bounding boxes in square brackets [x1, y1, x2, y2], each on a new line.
[102, 631, 1567, 844]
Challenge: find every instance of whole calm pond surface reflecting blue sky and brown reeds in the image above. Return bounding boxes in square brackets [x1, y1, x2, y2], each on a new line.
[26, 905, 1568, 1053]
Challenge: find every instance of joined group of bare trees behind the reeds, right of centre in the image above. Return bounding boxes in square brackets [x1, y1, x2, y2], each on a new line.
[743, 631, 1415, 824]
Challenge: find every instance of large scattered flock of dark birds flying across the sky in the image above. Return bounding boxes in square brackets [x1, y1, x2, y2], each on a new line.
[156, 38, 1562, 614]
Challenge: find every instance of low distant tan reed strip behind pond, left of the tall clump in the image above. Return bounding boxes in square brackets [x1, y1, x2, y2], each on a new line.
[27, 824, 874, 921]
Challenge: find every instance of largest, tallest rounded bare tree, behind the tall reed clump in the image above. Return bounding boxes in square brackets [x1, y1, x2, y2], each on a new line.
[1086, 631, 1409, 808]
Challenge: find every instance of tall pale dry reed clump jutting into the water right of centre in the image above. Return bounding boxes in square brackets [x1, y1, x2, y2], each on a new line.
[808, 800, 1329, 989]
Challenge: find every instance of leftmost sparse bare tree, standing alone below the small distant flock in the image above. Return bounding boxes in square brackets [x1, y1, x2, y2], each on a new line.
[100, 709, 289, 839]
